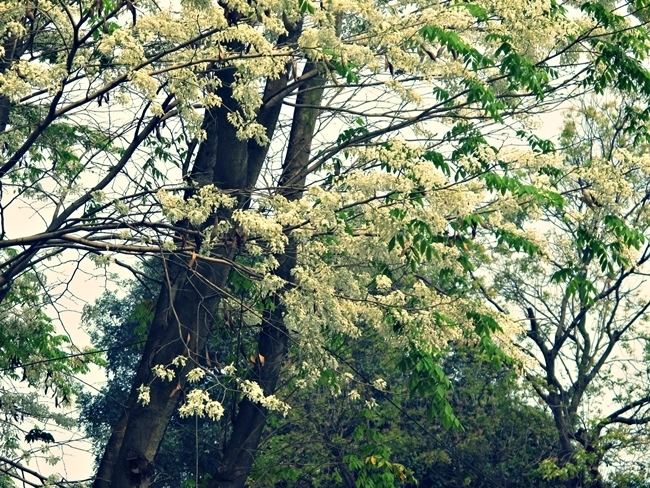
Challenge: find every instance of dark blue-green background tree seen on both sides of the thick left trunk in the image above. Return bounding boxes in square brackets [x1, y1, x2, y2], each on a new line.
[78, 272, 220, 487]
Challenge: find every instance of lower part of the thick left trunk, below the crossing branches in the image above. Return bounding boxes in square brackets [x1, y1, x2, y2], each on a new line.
[94, 254, 233, 488]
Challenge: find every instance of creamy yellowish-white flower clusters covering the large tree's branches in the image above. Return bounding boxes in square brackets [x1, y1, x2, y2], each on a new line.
[7, 0, 636, 438]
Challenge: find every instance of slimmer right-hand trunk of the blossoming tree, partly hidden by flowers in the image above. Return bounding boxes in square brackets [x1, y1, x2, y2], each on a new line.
[213, 63, 324, 488]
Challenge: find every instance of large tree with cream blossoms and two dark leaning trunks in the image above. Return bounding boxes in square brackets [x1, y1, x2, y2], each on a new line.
[0, 0, 650, 488]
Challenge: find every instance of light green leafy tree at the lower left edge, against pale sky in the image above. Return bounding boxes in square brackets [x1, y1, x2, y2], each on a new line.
[0, 264, 97, 487]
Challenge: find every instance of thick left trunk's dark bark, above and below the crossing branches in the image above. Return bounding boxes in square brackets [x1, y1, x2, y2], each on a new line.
[93, 67, 247, 488]
